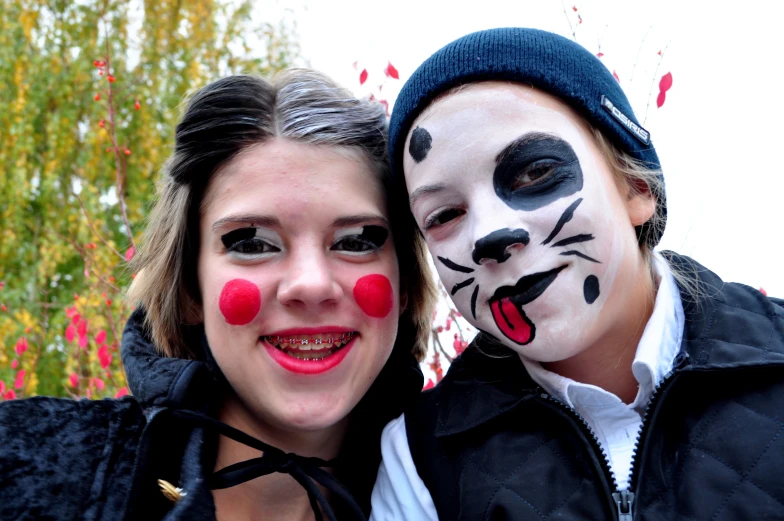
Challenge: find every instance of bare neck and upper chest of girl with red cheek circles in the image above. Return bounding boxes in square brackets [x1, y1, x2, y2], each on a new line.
[212, 396, 347, 521]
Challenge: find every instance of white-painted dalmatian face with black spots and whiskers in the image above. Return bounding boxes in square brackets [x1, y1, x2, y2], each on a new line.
[403, 82, 640, 362]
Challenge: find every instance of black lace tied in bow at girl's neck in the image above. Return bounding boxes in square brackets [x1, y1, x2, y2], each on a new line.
[172, 409, 366, 521]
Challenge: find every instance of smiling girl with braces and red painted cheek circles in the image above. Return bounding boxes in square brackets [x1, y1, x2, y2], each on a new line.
[0, 70, 434, 521]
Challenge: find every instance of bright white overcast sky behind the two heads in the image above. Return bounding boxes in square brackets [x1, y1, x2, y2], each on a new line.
[257, 0, 784, 296]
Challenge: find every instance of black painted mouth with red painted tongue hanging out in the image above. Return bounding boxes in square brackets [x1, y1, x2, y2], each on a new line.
[489, 265, 566, 345]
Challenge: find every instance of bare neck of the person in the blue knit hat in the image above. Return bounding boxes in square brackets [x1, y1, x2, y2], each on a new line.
[542, 259, 656, 403]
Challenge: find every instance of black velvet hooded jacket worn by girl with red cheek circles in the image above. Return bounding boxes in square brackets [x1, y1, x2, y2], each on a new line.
[0, 311, 422, 521]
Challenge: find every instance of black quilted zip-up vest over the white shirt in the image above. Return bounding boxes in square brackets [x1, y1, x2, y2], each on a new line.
[406, 254, 784, 521]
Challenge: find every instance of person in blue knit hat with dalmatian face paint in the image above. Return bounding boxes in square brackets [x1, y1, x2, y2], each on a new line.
[372, 29, 784, 521]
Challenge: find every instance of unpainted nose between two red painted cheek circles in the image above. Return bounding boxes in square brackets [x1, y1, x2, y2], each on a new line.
[277, 249, 343, 311]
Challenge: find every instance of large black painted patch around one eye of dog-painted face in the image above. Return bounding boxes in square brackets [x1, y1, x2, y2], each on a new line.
[496, 132, 583, 211]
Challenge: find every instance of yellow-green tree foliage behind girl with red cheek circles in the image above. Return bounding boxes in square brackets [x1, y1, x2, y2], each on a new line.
[0, 0, 299, 399]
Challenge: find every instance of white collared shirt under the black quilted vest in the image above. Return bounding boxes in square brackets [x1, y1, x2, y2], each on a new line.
[370, 253, 685, 521]
